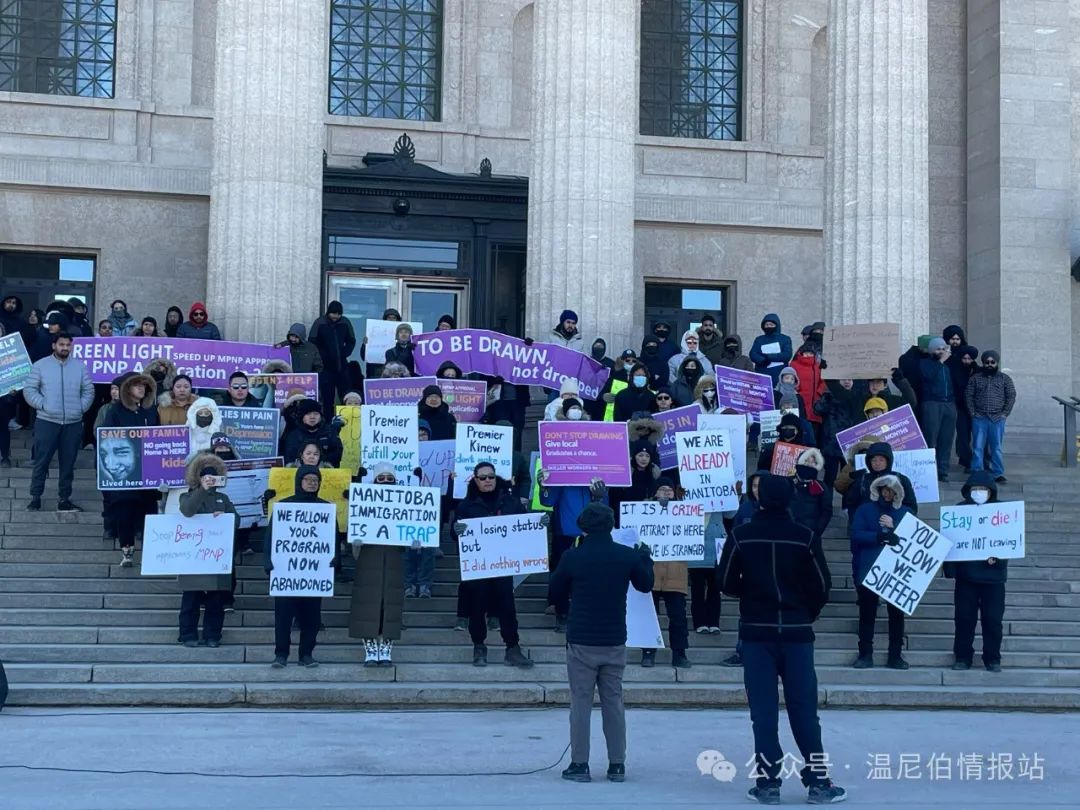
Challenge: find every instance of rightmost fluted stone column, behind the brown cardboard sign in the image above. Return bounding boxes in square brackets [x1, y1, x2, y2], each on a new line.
[825, 0, 930, 351]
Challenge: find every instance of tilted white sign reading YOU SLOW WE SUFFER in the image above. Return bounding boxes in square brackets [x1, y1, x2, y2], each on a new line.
[862, 514, 951, 616]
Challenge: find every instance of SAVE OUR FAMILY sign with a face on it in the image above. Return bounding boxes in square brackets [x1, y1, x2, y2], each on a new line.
[97, 426, 190, 491]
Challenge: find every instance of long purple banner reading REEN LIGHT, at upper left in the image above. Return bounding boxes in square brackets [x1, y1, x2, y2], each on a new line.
[71, 337, 292, 389]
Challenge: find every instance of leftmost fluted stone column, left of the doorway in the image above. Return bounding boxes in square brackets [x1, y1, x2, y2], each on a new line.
[206, 0, 328, 342]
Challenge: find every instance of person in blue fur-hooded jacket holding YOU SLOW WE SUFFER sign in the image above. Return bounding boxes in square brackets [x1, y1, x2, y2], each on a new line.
[851, 474, 914, 670]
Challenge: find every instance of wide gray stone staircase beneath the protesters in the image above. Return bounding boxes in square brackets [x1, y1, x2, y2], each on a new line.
[0, 431, 1080, 710]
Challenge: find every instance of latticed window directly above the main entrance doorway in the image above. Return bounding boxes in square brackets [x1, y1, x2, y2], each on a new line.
[329, 0, 443, 121]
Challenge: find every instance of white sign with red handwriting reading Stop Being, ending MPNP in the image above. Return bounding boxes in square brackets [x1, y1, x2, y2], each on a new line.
[139, 513, 237, 577]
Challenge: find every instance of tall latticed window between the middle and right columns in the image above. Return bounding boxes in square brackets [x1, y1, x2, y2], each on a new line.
[640, 0, 743, 140]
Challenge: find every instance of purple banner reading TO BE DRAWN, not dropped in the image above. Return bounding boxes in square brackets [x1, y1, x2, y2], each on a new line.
[413, 329, 609, 400]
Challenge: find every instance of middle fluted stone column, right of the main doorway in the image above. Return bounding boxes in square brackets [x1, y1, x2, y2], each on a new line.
[526, 0, 639, 352]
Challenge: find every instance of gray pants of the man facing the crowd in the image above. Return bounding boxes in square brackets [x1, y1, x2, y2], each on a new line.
[566, 644, 626, 765]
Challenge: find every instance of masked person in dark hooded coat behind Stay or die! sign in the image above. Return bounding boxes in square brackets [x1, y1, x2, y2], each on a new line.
[944, 471, 1009, 672]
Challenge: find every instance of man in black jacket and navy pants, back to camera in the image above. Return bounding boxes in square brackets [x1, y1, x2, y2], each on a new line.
[719, 475, 847, 805]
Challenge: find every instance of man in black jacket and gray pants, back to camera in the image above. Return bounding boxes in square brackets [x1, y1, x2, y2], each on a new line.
[549, 503, 652, 782]
